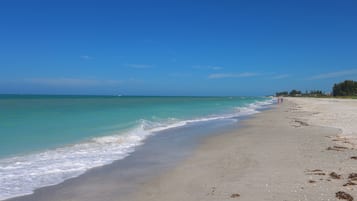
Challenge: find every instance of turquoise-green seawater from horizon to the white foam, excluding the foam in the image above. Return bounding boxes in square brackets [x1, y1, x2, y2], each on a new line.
[0, 96, 268, 157]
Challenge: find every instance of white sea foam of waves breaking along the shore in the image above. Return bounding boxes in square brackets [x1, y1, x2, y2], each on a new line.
[0, 100, 273, 200]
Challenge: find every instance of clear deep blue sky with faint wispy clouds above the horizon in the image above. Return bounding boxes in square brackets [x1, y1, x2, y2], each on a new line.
[0, 0, 357, 96]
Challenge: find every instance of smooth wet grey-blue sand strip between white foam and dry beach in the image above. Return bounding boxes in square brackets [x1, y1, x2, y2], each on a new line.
[6, 117, 246, 201]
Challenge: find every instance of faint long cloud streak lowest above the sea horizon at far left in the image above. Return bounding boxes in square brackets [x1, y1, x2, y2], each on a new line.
[25, 78, 121, 87]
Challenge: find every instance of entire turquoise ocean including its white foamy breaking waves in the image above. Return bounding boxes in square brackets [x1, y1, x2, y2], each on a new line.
[0, 95, 273, 200]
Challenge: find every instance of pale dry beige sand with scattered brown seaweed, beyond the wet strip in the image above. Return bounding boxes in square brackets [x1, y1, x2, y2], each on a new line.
[126, 98, 357, 201]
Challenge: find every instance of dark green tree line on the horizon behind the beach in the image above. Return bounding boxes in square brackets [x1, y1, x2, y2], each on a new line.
[275, 80, 357, 97]
